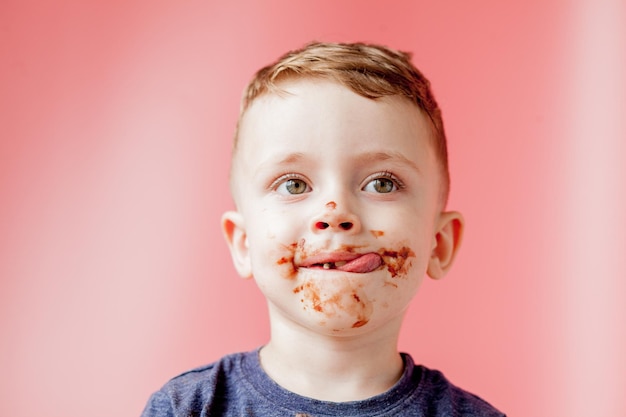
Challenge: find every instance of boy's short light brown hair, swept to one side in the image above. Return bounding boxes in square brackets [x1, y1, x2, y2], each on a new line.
[233, 42, 450, 205]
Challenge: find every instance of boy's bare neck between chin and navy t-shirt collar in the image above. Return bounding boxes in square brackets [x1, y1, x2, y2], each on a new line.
[260, 312, 404, 402]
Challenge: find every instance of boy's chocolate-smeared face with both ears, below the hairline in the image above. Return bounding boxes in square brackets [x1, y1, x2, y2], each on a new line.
[223, 80, 461, 335]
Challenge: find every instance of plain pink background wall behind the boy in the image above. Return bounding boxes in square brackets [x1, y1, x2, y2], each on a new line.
[0, 0, 626, 417]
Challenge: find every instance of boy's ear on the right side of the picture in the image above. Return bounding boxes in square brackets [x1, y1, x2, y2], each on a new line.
[426, 211, 464, 279]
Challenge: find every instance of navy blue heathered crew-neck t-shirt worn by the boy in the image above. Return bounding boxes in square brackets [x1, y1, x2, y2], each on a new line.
[142, 350, 504, 417]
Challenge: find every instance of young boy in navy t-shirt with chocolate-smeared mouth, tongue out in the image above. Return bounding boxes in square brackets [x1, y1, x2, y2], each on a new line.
[143, 43, 502, 417]
